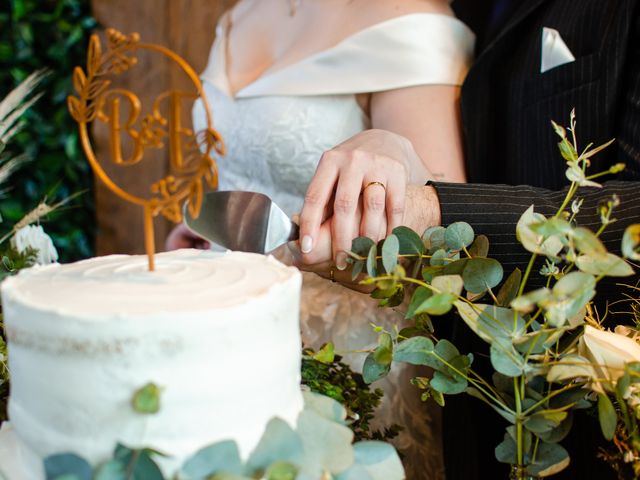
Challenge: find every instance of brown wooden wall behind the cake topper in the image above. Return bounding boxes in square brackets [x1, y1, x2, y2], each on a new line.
[92, 0, 235, 255]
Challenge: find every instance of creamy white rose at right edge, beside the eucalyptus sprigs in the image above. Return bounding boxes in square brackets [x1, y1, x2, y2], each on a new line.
[578, 325, 640, 390]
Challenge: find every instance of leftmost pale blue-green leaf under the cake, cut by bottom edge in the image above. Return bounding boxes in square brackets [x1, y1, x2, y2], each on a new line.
[180, 440, 243, 480]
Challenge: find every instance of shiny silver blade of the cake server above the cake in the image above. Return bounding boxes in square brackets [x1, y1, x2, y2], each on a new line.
[184, 191, 299, 253]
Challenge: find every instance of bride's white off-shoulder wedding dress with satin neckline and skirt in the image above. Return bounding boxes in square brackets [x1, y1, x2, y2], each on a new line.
[193, 13, 474, 480]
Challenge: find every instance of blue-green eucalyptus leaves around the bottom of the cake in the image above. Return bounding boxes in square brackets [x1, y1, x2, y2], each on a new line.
[44, 384, 404, 480]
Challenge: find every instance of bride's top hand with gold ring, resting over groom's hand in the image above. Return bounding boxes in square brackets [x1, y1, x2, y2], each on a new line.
[300, 130, 429, 270]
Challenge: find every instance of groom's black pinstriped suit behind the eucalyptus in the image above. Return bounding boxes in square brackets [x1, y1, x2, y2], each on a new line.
[435, 0, 640, 480]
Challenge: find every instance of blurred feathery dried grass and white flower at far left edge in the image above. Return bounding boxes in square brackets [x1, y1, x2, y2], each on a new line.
[0, 71, 63, 423]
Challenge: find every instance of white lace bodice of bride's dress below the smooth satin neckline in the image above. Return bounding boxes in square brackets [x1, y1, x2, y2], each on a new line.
[195, 90, 370, 215]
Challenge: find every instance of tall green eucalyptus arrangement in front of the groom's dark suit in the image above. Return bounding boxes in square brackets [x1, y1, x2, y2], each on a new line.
[350, 112, 640, 479]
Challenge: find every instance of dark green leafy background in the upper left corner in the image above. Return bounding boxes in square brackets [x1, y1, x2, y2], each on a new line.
[0, 0, 96, 261]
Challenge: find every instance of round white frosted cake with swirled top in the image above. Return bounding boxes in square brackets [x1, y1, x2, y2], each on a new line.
[2, 250, 303, 474]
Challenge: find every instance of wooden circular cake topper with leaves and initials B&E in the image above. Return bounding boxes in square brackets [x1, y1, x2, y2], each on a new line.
[67, 29, 224, 271]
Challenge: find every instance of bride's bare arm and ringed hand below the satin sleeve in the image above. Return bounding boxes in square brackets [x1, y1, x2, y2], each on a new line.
[300, 86, 465, 269]
